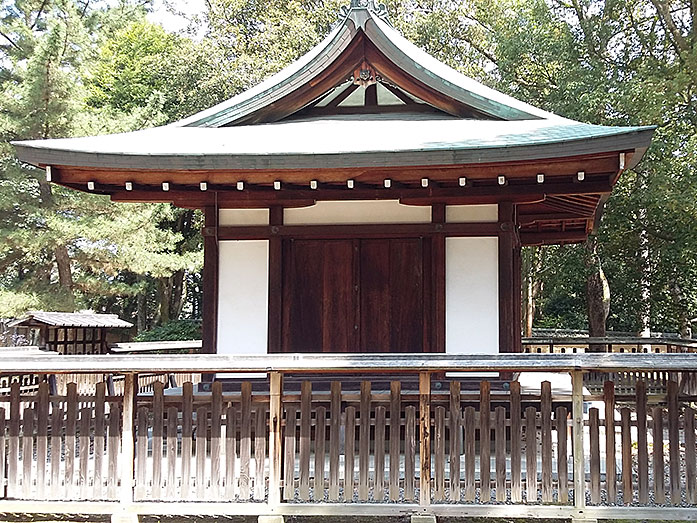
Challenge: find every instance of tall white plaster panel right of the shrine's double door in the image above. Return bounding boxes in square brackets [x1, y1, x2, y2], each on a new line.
[445, 237, 499, 354]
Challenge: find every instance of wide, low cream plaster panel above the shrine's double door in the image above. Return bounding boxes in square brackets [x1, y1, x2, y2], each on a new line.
[283, 200, 431, 225]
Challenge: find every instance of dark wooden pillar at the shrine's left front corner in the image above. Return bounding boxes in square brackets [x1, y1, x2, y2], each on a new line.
[201, 207, 219, 354]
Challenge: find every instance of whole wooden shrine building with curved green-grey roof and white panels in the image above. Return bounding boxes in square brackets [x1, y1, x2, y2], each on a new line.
[15, 0, 654, 354]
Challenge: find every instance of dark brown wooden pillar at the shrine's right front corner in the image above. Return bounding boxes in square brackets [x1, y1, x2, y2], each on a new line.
[498, 202, 521, 352]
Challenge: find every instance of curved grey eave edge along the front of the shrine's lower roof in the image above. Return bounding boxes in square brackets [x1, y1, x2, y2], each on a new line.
[13, 122, 654, 170]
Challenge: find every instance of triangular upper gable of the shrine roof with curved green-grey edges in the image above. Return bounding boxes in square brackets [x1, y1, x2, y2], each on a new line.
[177, 0, 560, 127]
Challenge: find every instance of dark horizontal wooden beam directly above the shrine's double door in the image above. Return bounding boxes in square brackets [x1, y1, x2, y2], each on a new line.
[215, 222, 499, 240]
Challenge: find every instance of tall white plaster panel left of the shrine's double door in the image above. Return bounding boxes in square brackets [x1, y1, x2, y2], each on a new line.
[217, 240, 269, 354]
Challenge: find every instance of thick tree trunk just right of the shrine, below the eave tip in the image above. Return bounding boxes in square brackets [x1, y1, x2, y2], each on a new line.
[585, 237, 610, 352]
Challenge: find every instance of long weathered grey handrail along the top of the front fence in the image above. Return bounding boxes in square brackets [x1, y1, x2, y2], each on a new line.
[0, 353, 697, 374]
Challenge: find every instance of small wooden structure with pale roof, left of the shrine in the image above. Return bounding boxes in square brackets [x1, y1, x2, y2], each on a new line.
[8, 311, 133, 354]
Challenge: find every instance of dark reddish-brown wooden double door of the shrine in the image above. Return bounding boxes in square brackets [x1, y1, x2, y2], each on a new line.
[281, 238, 433, 353]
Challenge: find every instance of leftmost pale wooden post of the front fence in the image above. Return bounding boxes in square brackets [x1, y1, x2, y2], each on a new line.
[111, 374, 138, 523]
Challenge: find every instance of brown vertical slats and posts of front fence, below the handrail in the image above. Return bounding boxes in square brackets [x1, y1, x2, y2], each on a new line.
[0, 354, 697, 517]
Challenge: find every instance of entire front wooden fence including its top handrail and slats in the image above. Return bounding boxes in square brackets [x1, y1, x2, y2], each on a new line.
[0, 354, 697, 519]
